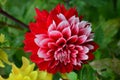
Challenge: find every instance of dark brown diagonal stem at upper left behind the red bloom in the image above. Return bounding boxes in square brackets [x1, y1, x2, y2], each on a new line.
[0, 8, 28, 29]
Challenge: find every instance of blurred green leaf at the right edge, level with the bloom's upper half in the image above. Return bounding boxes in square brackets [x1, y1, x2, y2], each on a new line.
[102, 19, 120, 46]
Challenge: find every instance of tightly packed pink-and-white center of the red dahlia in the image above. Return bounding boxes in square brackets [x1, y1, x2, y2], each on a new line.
[54, 48, 70, 65]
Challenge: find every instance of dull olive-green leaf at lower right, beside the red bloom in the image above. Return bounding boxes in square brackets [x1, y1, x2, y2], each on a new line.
[90, 58, 120, 76]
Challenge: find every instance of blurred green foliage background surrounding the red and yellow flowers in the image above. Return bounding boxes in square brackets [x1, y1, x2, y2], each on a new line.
[0, 0, 120, 80]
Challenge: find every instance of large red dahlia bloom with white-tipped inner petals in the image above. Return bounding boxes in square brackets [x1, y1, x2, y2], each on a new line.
[24, 5, 98, 73]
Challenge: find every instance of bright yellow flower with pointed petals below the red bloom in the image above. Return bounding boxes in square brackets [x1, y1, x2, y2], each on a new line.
[0, 57, 52, 80]
